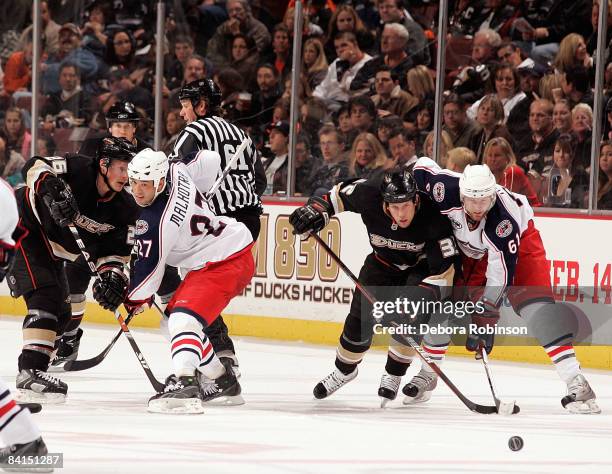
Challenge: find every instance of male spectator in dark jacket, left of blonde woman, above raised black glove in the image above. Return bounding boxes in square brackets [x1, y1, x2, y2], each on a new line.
[309, 125, 352, 196]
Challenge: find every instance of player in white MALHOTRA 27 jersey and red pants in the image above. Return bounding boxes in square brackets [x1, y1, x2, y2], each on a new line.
[124, 149, 255, 413]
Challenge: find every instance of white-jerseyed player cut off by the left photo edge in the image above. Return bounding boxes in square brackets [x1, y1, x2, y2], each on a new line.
[0, 178, 53, 472]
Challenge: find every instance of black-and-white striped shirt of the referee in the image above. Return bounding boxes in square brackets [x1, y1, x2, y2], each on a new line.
[170, 116, 261, 215]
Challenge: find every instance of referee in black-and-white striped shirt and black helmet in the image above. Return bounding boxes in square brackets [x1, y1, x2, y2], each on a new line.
[158, 79, 266, 375]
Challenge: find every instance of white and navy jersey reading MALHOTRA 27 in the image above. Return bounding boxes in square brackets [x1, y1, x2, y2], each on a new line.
[128, 163, 253, 301]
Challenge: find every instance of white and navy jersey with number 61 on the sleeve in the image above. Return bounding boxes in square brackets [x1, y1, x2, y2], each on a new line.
[413, 158, 533, 302]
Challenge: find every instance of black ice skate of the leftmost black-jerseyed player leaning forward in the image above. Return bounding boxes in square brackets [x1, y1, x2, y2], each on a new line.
[15, 369, 68, 404]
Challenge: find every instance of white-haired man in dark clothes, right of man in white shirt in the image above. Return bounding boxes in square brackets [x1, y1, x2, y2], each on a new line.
[351, 23, 414, 91]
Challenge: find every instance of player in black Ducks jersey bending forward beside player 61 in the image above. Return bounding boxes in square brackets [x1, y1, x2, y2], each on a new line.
[289, 169, 457, 406]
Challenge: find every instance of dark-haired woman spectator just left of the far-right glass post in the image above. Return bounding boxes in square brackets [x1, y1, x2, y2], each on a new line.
[542, 134, 589, 208]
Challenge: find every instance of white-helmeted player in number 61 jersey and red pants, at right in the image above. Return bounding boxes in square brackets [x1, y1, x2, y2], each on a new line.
[404, 158, 601, 413]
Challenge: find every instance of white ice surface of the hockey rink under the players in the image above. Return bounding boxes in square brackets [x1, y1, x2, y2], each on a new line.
[0, 317, 612, 474]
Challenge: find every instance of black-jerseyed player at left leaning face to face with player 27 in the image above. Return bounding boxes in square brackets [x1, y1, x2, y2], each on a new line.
[8, 138, 139, 403]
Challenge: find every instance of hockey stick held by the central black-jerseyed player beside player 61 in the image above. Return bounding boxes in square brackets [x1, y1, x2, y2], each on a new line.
[311, 234, 504, 415]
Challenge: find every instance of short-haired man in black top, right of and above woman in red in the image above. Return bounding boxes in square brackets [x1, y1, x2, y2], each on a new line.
[516, 99, 559, 177]
